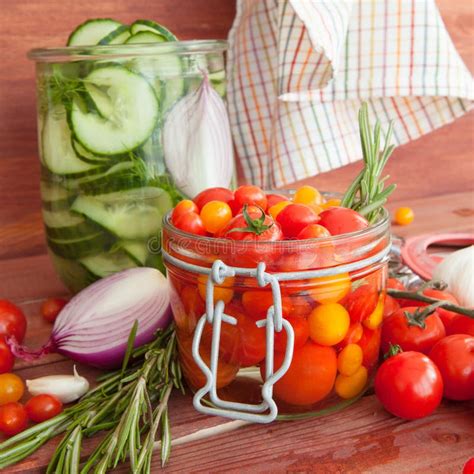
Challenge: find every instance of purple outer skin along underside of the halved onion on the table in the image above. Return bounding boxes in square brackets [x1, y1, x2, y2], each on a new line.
[57, 307, 172, 370]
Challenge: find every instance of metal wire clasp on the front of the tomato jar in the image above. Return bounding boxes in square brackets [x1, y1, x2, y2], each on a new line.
[192, 260, 294, 423]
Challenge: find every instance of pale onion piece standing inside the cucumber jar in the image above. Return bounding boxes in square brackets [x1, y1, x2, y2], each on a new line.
[163, 76, 234, 198]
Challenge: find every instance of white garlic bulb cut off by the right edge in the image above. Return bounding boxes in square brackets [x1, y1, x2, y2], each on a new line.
[433, 245, 474, 308]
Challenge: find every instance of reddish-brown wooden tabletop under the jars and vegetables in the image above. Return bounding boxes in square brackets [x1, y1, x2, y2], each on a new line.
[0, 192, 474, 474]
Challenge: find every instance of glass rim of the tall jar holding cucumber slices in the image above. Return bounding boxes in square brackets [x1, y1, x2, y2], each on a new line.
[27, 40, 228, 63]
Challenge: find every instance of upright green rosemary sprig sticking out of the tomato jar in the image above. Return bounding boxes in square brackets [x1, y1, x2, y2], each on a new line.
[341, 102, 396, 222]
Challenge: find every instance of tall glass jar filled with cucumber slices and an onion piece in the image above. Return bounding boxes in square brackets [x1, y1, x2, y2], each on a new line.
[29, 19, 233, 292]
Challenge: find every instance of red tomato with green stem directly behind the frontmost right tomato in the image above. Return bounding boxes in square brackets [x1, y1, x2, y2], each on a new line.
[382, 307, 446, 354]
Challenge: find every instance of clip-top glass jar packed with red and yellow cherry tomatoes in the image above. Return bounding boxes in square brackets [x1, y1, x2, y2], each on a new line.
[163, 189, 390, 418]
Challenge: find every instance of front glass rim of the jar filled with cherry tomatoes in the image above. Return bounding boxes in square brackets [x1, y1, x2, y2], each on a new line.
[163, 208, 390, 246]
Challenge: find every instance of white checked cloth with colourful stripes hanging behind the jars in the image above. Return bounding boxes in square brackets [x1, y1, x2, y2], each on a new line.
[228, 0, 474, 188]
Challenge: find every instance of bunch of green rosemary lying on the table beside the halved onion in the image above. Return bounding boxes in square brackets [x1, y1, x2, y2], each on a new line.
[0, 326, 184, 474]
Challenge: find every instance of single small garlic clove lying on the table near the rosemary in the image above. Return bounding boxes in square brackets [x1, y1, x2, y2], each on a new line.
[26, 366, 89, 403]
